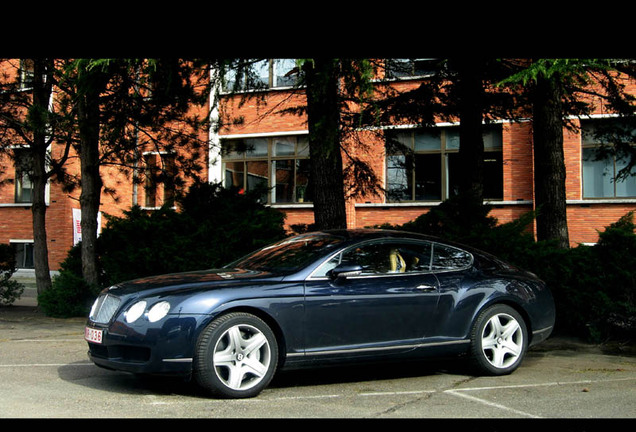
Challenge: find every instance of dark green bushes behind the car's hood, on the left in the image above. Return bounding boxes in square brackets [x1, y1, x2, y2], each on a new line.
[38, 183, 285, 316]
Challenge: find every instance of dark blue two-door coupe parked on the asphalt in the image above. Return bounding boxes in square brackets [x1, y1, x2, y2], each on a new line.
[85, 230, 555, 398]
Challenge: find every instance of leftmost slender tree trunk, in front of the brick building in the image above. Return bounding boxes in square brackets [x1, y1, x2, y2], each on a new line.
[29, 59, 52, 294]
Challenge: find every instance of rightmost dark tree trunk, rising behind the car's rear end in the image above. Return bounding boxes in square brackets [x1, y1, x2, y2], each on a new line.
[533, 74, 570, 248]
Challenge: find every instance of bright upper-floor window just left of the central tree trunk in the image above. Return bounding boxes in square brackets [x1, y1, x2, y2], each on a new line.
[223, 59, 299, 92]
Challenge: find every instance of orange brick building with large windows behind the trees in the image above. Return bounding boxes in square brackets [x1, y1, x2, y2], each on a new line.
[0, 60, 636, 269]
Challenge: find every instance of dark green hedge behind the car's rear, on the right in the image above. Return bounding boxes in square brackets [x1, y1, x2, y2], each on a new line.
[392, 199, 636, 342]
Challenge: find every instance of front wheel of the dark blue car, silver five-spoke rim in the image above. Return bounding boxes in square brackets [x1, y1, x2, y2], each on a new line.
[194, 312, 278, 398]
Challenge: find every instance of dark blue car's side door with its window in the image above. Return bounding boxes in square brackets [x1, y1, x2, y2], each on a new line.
[305, 241, 438, 356]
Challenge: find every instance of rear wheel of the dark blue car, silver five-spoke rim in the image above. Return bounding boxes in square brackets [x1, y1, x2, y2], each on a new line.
[471, 305, 528, 375]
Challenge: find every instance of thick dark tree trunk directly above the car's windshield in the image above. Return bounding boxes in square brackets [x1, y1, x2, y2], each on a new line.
[305, 59, 347, 230]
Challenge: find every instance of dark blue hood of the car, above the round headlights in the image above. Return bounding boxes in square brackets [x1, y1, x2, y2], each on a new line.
[107, 269, 283, 296]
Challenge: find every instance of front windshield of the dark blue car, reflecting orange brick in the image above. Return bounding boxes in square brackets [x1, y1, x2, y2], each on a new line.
[226, 233, 345, 273]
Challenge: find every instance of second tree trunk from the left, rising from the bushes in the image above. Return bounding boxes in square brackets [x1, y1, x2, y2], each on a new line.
[78, 88, 103, 286]
